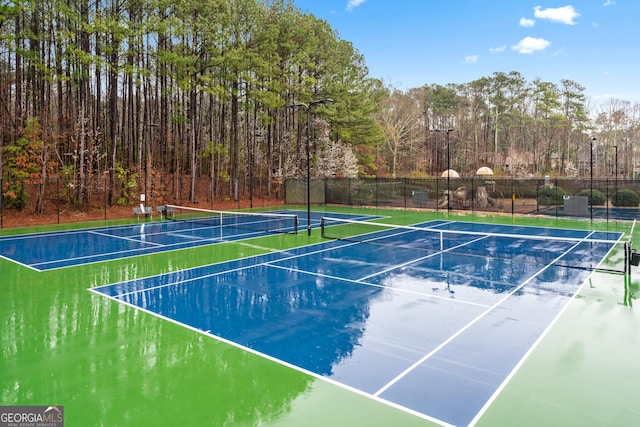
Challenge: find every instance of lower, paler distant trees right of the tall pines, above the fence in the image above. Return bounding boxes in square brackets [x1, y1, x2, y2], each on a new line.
[376, 75, 640, 179]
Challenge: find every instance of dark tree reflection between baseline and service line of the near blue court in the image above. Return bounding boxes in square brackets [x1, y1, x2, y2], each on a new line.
[115, 265, 382, 375]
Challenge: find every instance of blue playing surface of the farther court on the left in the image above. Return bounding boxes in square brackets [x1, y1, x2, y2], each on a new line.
[0, 210, 373, 271]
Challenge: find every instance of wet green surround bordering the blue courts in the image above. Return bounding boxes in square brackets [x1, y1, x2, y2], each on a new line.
[0, 207, 640, 427]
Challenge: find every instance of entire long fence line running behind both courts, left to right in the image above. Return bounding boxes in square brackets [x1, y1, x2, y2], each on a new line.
[0, 176, 640, 228]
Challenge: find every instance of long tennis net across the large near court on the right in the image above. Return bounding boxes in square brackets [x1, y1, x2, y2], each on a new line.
[321, 217, 629, 274]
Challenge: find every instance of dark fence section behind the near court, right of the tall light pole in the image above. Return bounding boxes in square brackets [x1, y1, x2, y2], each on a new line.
[285, 176, 640, 220]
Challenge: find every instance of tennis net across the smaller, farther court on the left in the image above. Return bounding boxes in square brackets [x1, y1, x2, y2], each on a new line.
[165, 205, 298, 234]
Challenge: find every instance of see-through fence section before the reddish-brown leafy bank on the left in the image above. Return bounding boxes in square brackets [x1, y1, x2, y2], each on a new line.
[0, 175, 284, 228]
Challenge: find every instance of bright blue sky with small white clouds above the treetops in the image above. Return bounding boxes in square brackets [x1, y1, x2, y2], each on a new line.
[293, 0, 640, 103]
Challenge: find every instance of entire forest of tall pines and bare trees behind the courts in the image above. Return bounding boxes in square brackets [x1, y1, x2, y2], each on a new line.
[0, 0, 640, 213]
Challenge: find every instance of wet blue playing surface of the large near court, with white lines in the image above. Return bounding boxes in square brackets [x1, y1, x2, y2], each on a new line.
[91, 221, 621, 425]
